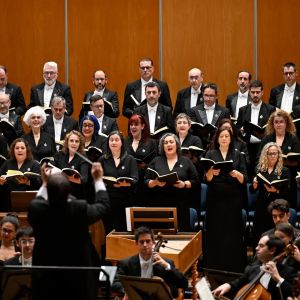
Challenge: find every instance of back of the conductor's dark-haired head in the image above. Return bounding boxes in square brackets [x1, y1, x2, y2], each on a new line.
[47, 174, 71, 206]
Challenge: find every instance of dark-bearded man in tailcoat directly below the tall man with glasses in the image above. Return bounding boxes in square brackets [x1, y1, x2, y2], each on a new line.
[134, 81, 174, 139]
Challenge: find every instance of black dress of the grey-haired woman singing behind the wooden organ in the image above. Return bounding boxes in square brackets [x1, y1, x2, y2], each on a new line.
[146, 155, 199, 231]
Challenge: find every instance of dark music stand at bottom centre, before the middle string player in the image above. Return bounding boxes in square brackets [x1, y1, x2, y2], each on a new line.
[119, 275, 173, 300]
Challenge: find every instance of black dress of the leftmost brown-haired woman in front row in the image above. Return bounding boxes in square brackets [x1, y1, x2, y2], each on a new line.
[0, 159, 42, 211]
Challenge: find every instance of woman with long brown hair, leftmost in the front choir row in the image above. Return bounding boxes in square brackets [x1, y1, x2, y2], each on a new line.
[0, 138, 41, 211]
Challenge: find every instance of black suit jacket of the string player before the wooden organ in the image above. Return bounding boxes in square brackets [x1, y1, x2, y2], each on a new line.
[112, 255, 187, 298]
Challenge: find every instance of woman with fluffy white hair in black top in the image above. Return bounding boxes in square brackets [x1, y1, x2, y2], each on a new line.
[23, 106, 56, 161]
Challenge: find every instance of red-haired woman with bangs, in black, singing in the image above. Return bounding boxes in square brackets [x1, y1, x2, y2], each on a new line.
[125, 113, 157, 206]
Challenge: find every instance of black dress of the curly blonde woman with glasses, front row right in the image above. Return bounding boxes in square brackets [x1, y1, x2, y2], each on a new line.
[253, 167, 290, 245]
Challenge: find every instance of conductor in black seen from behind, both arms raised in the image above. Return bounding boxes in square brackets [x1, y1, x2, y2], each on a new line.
[28, 163, 110, 300]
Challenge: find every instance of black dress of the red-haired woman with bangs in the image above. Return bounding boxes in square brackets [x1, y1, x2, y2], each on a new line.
[125, 136, 158, 206]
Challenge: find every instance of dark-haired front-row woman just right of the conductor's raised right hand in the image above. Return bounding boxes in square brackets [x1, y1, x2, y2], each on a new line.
[100, 131, 138, 233]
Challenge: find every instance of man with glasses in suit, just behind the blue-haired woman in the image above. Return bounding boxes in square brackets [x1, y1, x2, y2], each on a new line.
[90, 95, 119, 135]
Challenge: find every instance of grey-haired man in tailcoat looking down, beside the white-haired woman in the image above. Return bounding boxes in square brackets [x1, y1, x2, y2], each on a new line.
[43, 96, 78, 149]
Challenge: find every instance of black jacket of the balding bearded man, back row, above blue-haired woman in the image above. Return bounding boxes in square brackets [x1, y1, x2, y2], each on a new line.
[79, 88, 120, 121]
